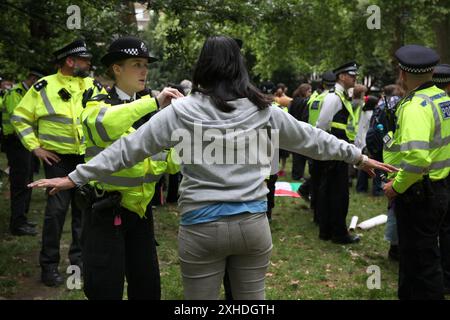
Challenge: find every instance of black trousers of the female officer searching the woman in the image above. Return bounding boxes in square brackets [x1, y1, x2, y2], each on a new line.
[82, 204, 161, 300]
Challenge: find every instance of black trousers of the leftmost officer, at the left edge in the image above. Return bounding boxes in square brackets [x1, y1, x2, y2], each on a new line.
[4, 134, 34, 231]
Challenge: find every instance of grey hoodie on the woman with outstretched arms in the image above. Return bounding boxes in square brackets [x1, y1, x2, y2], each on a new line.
[69, 93, 361, 214]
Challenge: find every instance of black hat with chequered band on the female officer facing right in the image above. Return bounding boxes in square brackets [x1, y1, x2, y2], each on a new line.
[101, 37, 158, 67]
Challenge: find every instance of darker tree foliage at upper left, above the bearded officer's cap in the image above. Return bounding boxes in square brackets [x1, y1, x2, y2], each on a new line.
[0, 0, 136, 79]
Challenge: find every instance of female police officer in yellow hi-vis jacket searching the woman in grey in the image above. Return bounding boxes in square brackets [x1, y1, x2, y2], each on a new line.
[77, 37, 182, 300]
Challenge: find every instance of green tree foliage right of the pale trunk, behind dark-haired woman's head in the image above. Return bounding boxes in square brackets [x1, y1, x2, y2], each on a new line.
[146, 0, 450, 89]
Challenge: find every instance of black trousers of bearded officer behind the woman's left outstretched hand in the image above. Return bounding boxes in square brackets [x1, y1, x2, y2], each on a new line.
[39, 154, 84, 269]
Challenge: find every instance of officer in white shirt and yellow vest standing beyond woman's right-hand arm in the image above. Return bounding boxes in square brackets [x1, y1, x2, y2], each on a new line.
[317, 61, 360, 244]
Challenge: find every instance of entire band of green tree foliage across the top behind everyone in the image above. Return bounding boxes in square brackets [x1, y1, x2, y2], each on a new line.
[0, 0, 450, 90]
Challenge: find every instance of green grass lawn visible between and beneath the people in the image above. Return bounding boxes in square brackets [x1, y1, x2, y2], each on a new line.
[0, 154, 398, 300]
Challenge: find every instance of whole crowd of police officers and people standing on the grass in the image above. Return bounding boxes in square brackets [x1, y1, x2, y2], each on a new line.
[2, 36, 450, 300]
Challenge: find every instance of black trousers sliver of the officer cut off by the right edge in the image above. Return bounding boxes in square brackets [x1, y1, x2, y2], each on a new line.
[439, 175, 450, 292]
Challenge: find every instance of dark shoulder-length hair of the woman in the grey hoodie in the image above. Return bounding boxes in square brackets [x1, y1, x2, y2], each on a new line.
[192, 36, 272, 112]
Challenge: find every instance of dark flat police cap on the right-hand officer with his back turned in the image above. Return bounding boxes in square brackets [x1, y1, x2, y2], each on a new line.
[395, 44, 440, 74]
